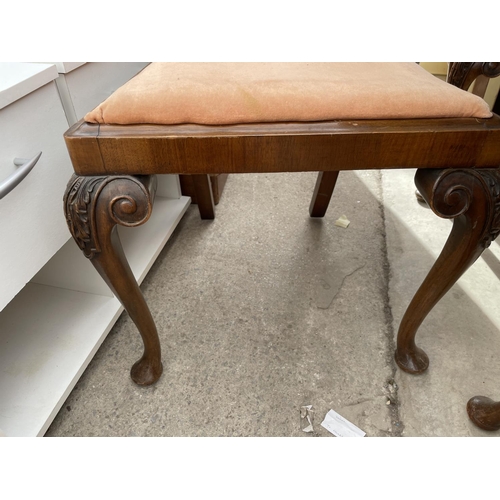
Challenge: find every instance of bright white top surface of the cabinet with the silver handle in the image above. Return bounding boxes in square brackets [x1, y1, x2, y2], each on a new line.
[0, 62, 59, 109]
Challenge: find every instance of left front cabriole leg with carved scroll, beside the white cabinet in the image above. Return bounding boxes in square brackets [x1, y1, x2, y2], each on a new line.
[64, 175, 163, 385]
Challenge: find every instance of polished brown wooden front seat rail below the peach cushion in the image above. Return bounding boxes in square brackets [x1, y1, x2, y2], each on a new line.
[65, 115, 500, 175]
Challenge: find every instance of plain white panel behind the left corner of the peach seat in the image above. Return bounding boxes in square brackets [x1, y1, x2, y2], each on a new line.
[60, 62, 149, 120]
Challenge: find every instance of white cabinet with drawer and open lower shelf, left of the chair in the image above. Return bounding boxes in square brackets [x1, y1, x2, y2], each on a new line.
[0, 63, 190, 436]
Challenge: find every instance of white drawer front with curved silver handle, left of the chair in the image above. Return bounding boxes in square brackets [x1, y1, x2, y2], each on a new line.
[0, 83, 73, 310]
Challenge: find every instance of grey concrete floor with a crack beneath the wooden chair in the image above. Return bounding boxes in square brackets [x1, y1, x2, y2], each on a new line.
[46, 170, 500, 437]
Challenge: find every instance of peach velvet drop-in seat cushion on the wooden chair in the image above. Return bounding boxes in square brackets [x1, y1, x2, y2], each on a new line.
[85, 63, 492, 125]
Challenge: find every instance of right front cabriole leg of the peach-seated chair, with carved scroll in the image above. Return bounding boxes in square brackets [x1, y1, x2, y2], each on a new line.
[395, 169, 500, 374]
